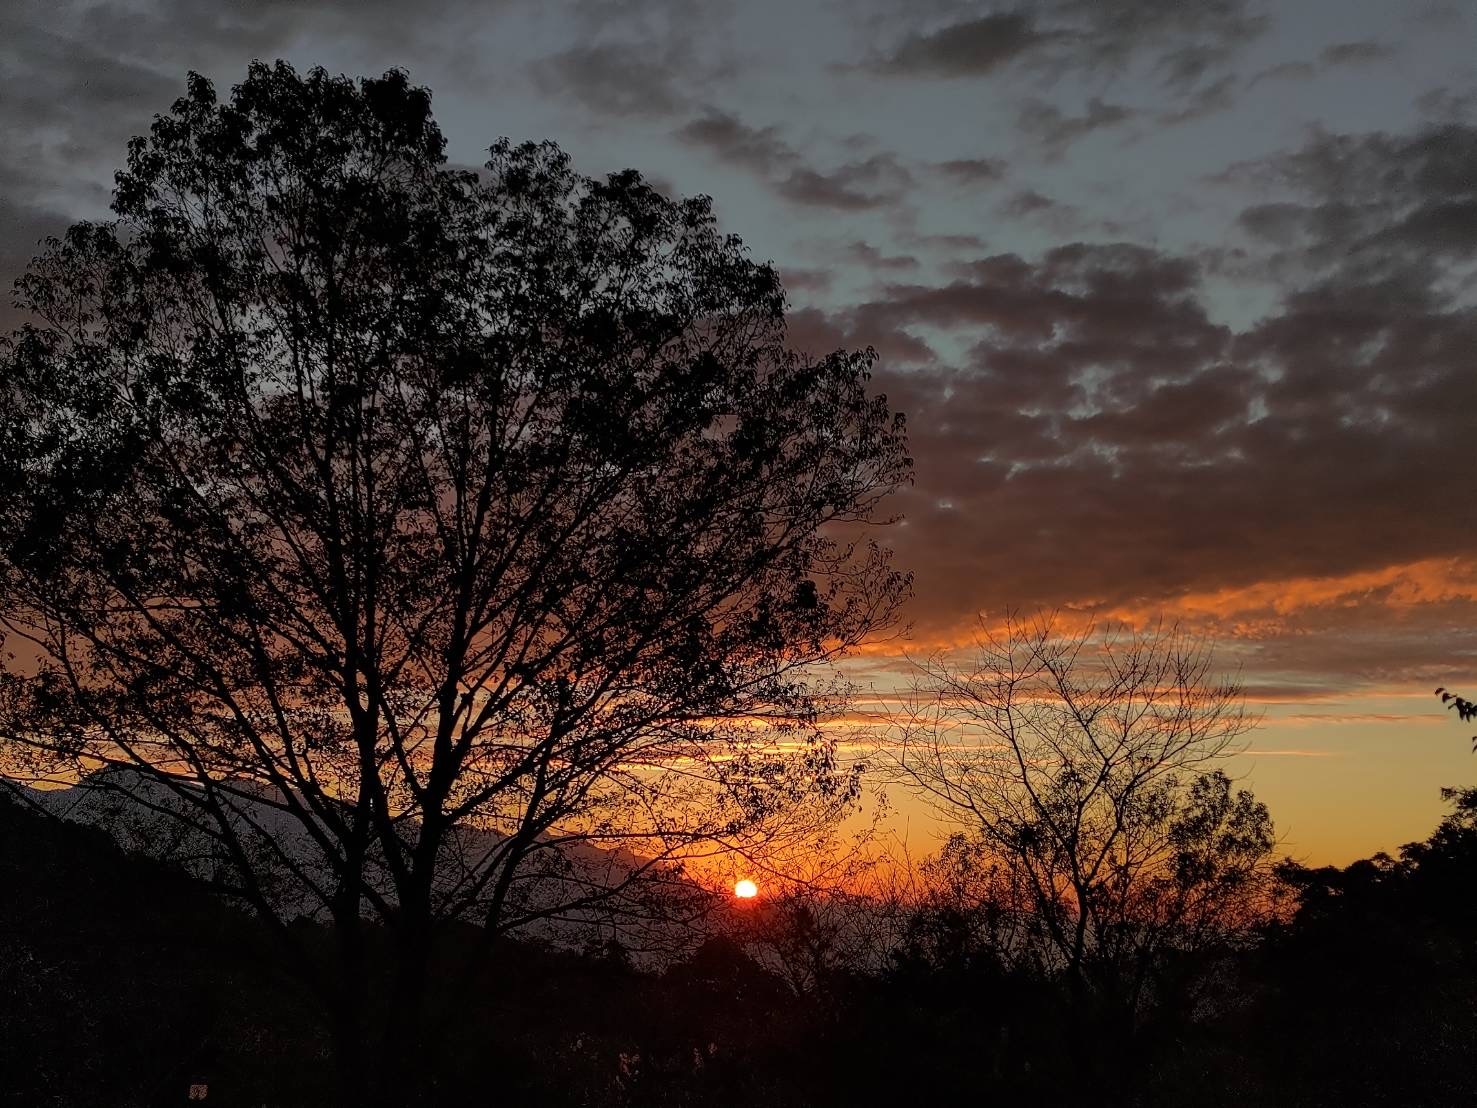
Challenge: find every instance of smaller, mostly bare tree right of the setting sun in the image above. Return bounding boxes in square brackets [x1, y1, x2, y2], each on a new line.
[885, 620, 1275, 1040]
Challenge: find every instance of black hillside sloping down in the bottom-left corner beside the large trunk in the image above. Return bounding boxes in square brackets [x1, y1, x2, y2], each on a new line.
[0, 799, 326, 1105]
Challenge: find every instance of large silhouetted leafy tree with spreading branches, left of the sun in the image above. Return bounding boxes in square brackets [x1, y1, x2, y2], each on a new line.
[0, 62, 908, 1104]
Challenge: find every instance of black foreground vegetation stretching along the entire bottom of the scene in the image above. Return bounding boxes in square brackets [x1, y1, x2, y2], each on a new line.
[0, 790, 1477, 1105]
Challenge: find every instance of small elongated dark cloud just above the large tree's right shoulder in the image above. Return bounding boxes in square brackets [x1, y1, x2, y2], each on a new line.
[675, 109, 913, 211]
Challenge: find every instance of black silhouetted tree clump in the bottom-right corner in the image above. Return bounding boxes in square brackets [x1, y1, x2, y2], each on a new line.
[1246, 789, 1477, 1108]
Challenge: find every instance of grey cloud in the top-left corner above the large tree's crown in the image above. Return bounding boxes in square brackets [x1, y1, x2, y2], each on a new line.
[0, 0, 505, 319]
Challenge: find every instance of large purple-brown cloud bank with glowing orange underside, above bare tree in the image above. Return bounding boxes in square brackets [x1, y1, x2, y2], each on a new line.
[830, 195, 1477, 687]
